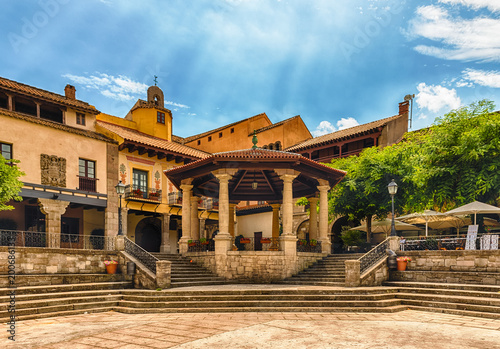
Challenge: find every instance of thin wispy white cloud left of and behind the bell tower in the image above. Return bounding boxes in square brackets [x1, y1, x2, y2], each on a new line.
[63, 73, 148, 101]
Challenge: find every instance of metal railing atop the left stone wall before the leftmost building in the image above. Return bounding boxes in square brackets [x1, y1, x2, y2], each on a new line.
[0, 230, 115, 251]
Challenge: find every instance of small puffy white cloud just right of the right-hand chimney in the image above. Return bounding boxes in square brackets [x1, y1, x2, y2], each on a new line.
[415, 82, 462, 113]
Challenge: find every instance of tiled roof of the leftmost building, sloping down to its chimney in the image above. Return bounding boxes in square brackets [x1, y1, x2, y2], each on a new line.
[0, 77, 99, 114]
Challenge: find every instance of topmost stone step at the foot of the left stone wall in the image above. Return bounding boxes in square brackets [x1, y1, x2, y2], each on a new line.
[0, 274, 125, 287]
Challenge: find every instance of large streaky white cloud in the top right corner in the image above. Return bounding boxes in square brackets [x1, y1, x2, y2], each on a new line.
[408, 5, 500, 61]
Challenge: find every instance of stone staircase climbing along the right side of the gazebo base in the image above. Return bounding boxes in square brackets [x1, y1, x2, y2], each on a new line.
[279, 253, 363, 286]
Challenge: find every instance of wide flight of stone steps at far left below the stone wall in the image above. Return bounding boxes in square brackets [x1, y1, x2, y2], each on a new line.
[0, 274, 133, 321]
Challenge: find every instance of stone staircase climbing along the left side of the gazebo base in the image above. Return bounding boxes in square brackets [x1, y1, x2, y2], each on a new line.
[152, 253, 225, 287]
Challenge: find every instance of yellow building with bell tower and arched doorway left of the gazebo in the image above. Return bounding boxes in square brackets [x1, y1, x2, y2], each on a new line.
[96, 86, 218, 253]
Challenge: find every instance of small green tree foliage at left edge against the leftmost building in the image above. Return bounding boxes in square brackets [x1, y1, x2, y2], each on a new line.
[0, 155, 24, 211]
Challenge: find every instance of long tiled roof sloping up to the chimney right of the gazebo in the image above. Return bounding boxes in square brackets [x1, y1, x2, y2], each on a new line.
[285, 115, 401, 151]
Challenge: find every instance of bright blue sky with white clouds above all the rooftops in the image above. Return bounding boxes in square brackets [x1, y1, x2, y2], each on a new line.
[0, 0, 500, 137]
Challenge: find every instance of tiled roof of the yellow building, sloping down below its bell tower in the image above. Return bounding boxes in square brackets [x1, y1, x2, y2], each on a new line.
[97, 120, 210, 158]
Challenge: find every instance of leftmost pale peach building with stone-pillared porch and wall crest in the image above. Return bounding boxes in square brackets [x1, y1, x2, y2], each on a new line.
[0, 78, 118, 247]
